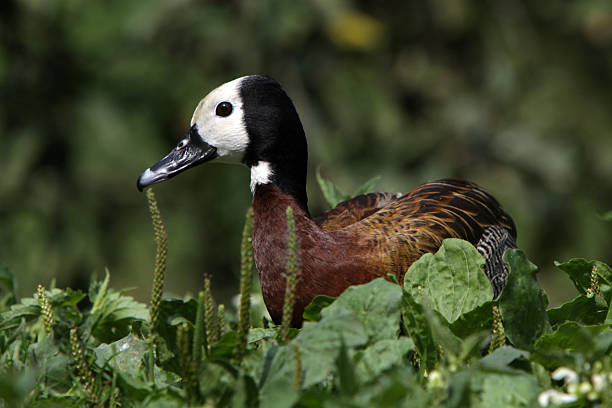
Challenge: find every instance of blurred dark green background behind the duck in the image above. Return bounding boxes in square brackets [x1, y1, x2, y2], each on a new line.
[0, 0, 612, 304]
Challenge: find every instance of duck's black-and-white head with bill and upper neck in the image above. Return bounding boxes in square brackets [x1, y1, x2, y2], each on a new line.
[137, 75, 308, 211]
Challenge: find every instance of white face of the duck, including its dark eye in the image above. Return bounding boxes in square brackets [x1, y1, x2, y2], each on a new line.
[191, 77, 249, 161]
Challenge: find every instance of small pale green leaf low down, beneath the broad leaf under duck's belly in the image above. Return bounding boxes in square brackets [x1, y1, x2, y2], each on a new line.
[356, 336, 415, 382]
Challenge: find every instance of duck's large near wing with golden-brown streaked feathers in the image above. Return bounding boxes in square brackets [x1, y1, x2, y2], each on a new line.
[347, 179, 516, 294]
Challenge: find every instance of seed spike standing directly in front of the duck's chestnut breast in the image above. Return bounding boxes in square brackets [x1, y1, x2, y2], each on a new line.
[278, 207, 297, 344]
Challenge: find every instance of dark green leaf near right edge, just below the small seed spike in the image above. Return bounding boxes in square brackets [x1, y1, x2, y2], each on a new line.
[547, 295, 608, 327]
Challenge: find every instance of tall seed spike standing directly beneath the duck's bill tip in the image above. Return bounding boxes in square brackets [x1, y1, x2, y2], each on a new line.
[146, 188, 168, 328]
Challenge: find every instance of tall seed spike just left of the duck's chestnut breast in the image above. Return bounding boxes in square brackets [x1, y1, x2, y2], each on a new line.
[234, 207, 253, 361]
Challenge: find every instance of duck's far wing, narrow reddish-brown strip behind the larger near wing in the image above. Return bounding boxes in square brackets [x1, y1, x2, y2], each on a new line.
[314, 193, 401, 231]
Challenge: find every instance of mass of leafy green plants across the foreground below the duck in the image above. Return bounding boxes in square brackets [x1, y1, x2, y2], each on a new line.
[0, 250, 612, 407]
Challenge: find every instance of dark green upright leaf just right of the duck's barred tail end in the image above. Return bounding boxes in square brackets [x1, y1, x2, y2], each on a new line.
[499, 249, 550, 350]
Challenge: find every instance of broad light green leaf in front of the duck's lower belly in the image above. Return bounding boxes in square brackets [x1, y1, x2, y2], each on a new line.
[321, 278, 402, 342]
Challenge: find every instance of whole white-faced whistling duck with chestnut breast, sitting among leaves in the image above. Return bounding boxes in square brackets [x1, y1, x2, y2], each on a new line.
[138, 75, 516, 326]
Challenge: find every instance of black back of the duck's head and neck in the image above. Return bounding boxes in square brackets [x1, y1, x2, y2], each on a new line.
[240, 75, 308, 211]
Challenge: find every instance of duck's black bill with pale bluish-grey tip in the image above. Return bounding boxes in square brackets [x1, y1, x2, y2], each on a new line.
[137, 132, 217, 191]
